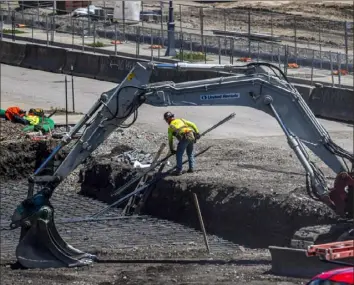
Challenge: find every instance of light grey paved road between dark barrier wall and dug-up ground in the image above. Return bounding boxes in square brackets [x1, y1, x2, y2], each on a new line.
[1, 64, 353, 149]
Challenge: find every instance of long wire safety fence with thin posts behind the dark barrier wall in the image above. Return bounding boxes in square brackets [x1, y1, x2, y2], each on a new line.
[1, 6, 353, 75]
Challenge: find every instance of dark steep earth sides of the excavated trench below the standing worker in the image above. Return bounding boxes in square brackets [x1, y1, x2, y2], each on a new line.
[0, 139, 334, 248]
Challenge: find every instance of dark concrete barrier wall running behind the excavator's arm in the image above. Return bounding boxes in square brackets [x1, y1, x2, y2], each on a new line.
[0, 41, 354, 122]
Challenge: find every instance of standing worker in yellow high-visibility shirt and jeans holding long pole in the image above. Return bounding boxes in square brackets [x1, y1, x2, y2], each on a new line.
[163, 112, 200, 175]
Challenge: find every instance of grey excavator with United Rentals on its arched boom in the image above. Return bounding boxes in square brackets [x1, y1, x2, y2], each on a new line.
[10, 62, 354, 274]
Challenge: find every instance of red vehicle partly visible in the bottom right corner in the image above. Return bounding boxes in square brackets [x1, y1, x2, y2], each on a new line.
[306, 266, 354, 285]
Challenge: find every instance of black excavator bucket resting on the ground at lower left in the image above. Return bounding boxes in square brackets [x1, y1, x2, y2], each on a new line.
[16, 206, 96, 268]
